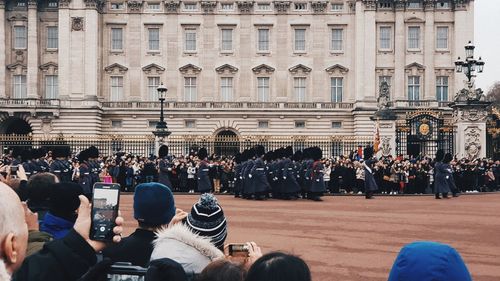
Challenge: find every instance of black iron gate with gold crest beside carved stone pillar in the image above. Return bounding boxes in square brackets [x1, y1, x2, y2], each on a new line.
[396, 112, 454, 158]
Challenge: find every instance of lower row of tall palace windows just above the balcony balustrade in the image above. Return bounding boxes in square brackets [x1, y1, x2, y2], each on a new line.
[8, 75, 449, 102]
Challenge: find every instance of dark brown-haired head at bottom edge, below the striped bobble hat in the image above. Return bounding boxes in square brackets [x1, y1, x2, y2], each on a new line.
[195, 260, 246, 281]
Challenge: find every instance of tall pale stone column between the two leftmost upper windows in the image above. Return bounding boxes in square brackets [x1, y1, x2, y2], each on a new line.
[27, 0, 38, 98]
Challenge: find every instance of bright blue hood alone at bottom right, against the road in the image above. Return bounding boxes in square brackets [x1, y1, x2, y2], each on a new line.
[388, 242, 472, 281]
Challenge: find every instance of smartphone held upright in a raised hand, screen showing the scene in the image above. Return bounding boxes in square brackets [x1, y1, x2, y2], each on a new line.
[90, 182, 120, 241]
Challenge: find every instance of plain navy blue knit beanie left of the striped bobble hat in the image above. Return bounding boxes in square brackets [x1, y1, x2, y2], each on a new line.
[134, 182, 175, 225]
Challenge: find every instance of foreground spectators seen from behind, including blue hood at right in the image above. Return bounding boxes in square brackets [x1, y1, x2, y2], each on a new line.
[0, 165, 472, 281]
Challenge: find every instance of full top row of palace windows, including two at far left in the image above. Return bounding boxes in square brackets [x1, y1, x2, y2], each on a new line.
[9, 25, 449, 52]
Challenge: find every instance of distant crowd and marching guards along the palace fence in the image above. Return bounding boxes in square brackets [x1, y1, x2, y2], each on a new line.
[0, 146, 500, 200]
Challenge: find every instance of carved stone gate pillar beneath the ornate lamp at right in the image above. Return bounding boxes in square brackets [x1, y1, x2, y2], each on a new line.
[451, 101, 490, 160]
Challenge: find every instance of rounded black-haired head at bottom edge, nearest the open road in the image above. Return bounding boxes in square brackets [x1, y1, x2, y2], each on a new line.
[245, 252, 311, 281]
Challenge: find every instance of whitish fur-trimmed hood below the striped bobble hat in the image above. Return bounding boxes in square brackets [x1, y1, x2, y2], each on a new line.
[151, 223, 224, 274]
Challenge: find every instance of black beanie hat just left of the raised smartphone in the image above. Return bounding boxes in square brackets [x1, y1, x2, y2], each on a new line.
[49, 182, 83, 221]
